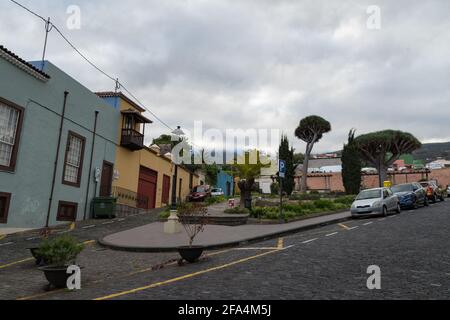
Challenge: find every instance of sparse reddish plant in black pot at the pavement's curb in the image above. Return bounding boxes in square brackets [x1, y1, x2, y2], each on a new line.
[178, 204, 208, 263]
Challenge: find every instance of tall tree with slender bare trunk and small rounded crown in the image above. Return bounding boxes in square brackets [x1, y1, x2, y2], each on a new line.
[295, 116, 331, 193]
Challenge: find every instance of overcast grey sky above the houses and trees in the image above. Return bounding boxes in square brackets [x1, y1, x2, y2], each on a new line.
[0, 0, 450, 152]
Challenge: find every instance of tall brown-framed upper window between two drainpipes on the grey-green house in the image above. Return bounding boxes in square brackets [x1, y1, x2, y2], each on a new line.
[63, 132, 86, 188]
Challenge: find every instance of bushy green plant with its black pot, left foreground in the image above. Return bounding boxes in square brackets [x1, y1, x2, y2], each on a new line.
[36, 235, 84, 289]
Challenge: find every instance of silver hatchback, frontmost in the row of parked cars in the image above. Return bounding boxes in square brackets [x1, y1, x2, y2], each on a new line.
[351, 188, 402, 218]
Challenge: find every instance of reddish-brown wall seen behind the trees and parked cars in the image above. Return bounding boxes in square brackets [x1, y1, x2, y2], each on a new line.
[295, 168, 450, 191]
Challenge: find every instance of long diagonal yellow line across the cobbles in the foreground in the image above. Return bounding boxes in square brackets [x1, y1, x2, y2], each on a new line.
[94, 249, 280, 301]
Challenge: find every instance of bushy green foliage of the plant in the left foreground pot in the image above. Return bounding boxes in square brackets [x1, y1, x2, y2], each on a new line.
[36, 235, 84, 267]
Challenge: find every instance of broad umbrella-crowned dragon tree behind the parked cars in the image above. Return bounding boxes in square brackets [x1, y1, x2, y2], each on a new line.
[354, 130, 422, 187]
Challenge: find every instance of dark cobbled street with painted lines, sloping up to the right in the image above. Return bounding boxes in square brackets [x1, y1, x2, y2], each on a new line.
[0, 201, 450, 300]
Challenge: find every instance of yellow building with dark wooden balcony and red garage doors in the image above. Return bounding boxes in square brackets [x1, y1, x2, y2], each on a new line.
[97, 92, 199, 210]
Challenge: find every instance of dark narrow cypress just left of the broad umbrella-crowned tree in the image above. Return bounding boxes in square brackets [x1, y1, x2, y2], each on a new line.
[342, 129, 362, 194]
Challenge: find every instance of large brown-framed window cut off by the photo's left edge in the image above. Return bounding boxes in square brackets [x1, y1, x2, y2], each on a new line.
[0, 98, 23, 171]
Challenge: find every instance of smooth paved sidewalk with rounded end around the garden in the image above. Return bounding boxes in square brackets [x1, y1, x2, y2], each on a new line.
[99, 212, 351, 252]
